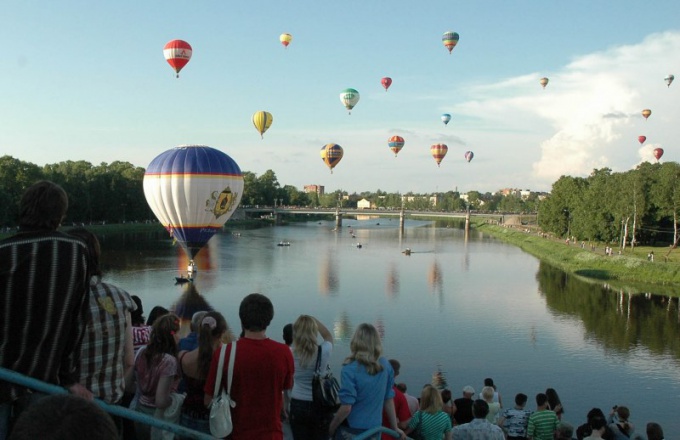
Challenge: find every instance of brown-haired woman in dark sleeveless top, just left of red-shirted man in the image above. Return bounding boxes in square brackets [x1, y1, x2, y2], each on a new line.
[178, 312, 229, 434]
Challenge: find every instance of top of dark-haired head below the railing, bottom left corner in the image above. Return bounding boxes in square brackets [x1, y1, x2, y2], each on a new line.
[9, 394, 118, 440]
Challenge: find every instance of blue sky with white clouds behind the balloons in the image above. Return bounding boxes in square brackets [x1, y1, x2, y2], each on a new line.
[0, 0, 680, 193]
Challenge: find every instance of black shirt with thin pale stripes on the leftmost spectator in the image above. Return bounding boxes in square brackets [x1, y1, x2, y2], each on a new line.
[0, 231, 88, 403]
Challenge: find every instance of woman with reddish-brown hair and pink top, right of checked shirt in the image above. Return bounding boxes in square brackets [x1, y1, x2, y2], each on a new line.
[134, 314, 180, 440]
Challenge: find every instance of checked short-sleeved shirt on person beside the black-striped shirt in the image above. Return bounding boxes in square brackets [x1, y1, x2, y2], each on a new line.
[80, 277, 137, 403]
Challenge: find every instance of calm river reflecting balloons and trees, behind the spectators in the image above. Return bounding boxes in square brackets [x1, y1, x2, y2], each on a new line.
[97, 218, 680, 438]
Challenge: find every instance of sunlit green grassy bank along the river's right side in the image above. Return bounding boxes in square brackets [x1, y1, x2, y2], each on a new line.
[474, 221, 680, 296]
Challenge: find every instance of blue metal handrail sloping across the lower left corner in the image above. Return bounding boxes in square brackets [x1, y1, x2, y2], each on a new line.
[0, 367, 215, 440]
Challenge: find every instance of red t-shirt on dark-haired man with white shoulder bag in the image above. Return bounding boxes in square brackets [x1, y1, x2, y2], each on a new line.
[204, 338, 294, 440]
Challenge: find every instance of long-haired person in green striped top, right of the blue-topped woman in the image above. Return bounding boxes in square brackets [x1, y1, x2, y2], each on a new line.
[406, 384, 452, 440]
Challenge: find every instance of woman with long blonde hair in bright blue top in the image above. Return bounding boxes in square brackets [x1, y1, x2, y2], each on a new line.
[329, 323, 405, 439]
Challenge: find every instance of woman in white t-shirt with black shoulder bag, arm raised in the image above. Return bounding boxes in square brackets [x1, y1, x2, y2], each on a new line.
[290, 315, 333, 440]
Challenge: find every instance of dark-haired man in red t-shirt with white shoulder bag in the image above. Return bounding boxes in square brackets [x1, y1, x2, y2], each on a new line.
[204, 293, 294, 440]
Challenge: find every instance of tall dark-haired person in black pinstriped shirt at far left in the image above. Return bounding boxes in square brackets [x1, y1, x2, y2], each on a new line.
[0, 180, 92, 440]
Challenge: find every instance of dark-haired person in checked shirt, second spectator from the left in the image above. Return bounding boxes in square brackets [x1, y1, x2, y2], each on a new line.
[68, 228, 136, 429]
